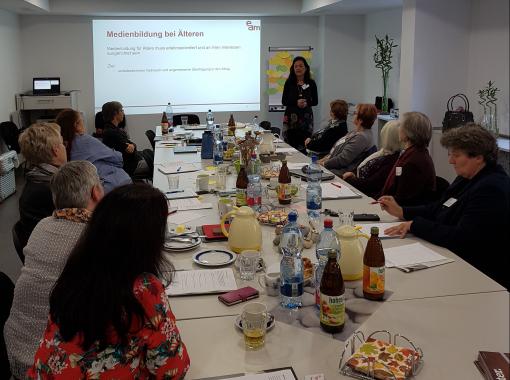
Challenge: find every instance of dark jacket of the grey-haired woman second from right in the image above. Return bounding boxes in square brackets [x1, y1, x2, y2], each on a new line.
[379, 146, 436, 206]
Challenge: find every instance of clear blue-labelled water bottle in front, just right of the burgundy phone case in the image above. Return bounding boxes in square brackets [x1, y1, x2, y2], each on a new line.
[280, 211, 303, 309]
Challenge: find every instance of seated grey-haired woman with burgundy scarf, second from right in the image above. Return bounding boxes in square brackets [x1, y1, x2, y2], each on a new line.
[379, 112, 436, 206]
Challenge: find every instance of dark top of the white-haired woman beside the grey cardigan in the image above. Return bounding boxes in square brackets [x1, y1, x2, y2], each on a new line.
[346, 152, 400, 198]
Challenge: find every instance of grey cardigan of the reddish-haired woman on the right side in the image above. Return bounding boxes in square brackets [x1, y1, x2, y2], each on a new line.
[324, 129, 374, 175]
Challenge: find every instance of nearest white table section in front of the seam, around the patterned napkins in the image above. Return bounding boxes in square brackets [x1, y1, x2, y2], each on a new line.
[177, 291, 509, 380]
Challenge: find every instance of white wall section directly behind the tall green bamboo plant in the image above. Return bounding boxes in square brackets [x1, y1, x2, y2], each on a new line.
[363, 8, 402, 108]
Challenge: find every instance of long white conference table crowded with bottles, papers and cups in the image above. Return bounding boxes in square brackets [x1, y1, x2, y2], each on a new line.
[153, 129, 510, 379]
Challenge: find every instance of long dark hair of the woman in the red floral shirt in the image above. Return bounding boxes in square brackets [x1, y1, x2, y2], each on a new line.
[50, 184, 173, 349]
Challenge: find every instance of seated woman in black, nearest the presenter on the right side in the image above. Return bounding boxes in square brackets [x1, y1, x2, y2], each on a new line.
[305, 99, 349, 155]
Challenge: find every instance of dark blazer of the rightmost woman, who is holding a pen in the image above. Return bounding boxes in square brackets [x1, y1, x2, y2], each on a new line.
[403, 165, 510, 289]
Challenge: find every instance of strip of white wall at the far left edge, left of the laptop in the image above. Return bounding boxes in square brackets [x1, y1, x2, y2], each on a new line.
[0, 9, 22, 122]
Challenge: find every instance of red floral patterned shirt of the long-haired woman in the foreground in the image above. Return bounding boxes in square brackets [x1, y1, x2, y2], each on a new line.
[27, 273, 190, 379]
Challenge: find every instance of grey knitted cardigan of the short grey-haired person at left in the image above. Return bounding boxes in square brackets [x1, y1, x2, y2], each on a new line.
[4, 216, 86, 379]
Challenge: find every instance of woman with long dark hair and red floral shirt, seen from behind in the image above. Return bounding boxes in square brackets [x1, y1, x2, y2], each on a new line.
[28, 184, 189, 379]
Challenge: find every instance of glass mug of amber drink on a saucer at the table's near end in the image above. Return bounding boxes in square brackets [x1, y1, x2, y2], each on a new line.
[241, 302, 268, 350]
